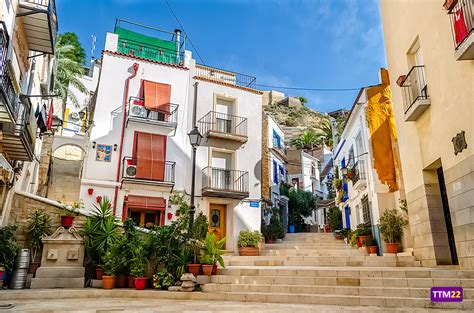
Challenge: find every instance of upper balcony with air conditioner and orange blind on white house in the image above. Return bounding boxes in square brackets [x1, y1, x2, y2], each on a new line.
[127, 97, 178, 134]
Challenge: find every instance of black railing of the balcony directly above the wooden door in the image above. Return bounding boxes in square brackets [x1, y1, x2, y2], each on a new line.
[202, 166, 249, 193]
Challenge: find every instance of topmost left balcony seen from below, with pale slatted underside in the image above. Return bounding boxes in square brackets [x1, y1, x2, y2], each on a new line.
[16, 0, 58, 54]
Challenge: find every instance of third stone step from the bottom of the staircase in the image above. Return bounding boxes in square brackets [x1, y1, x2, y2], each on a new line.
[220, 266, 474, 279]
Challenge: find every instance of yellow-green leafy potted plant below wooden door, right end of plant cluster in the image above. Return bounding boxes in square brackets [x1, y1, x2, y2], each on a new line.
[201, 233, 226, 275]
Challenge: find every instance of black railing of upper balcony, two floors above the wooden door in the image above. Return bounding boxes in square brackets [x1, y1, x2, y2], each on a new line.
[198, 111, 247, 137]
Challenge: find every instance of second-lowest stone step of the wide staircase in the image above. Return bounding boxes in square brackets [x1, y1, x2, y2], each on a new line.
[211, 275, 474, 288]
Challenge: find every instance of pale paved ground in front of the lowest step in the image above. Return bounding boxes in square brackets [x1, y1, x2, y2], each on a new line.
[0, 298, 466, 313]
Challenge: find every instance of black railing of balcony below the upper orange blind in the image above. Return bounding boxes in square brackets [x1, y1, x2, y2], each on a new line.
[127, 97, 178, 123]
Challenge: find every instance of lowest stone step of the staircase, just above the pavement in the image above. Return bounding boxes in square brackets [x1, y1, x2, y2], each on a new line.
[197, 292, 474, 310]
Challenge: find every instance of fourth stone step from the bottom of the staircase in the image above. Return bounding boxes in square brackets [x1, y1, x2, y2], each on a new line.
[224, 255, 420, 267]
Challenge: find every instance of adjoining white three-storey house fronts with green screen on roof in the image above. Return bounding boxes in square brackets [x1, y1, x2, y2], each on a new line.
[80, 21, 262, 250]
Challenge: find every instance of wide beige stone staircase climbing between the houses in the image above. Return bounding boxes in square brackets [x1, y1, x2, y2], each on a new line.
[203, 233, 474, 310]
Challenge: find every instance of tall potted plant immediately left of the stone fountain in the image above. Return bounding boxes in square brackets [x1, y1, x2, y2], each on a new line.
[26, 209, 51, 275]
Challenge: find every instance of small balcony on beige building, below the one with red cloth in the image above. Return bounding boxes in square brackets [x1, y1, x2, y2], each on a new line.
[399, 65, 431, 122]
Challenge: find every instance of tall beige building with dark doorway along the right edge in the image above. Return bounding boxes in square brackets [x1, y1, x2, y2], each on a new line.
[381, 0, 474, 269]
